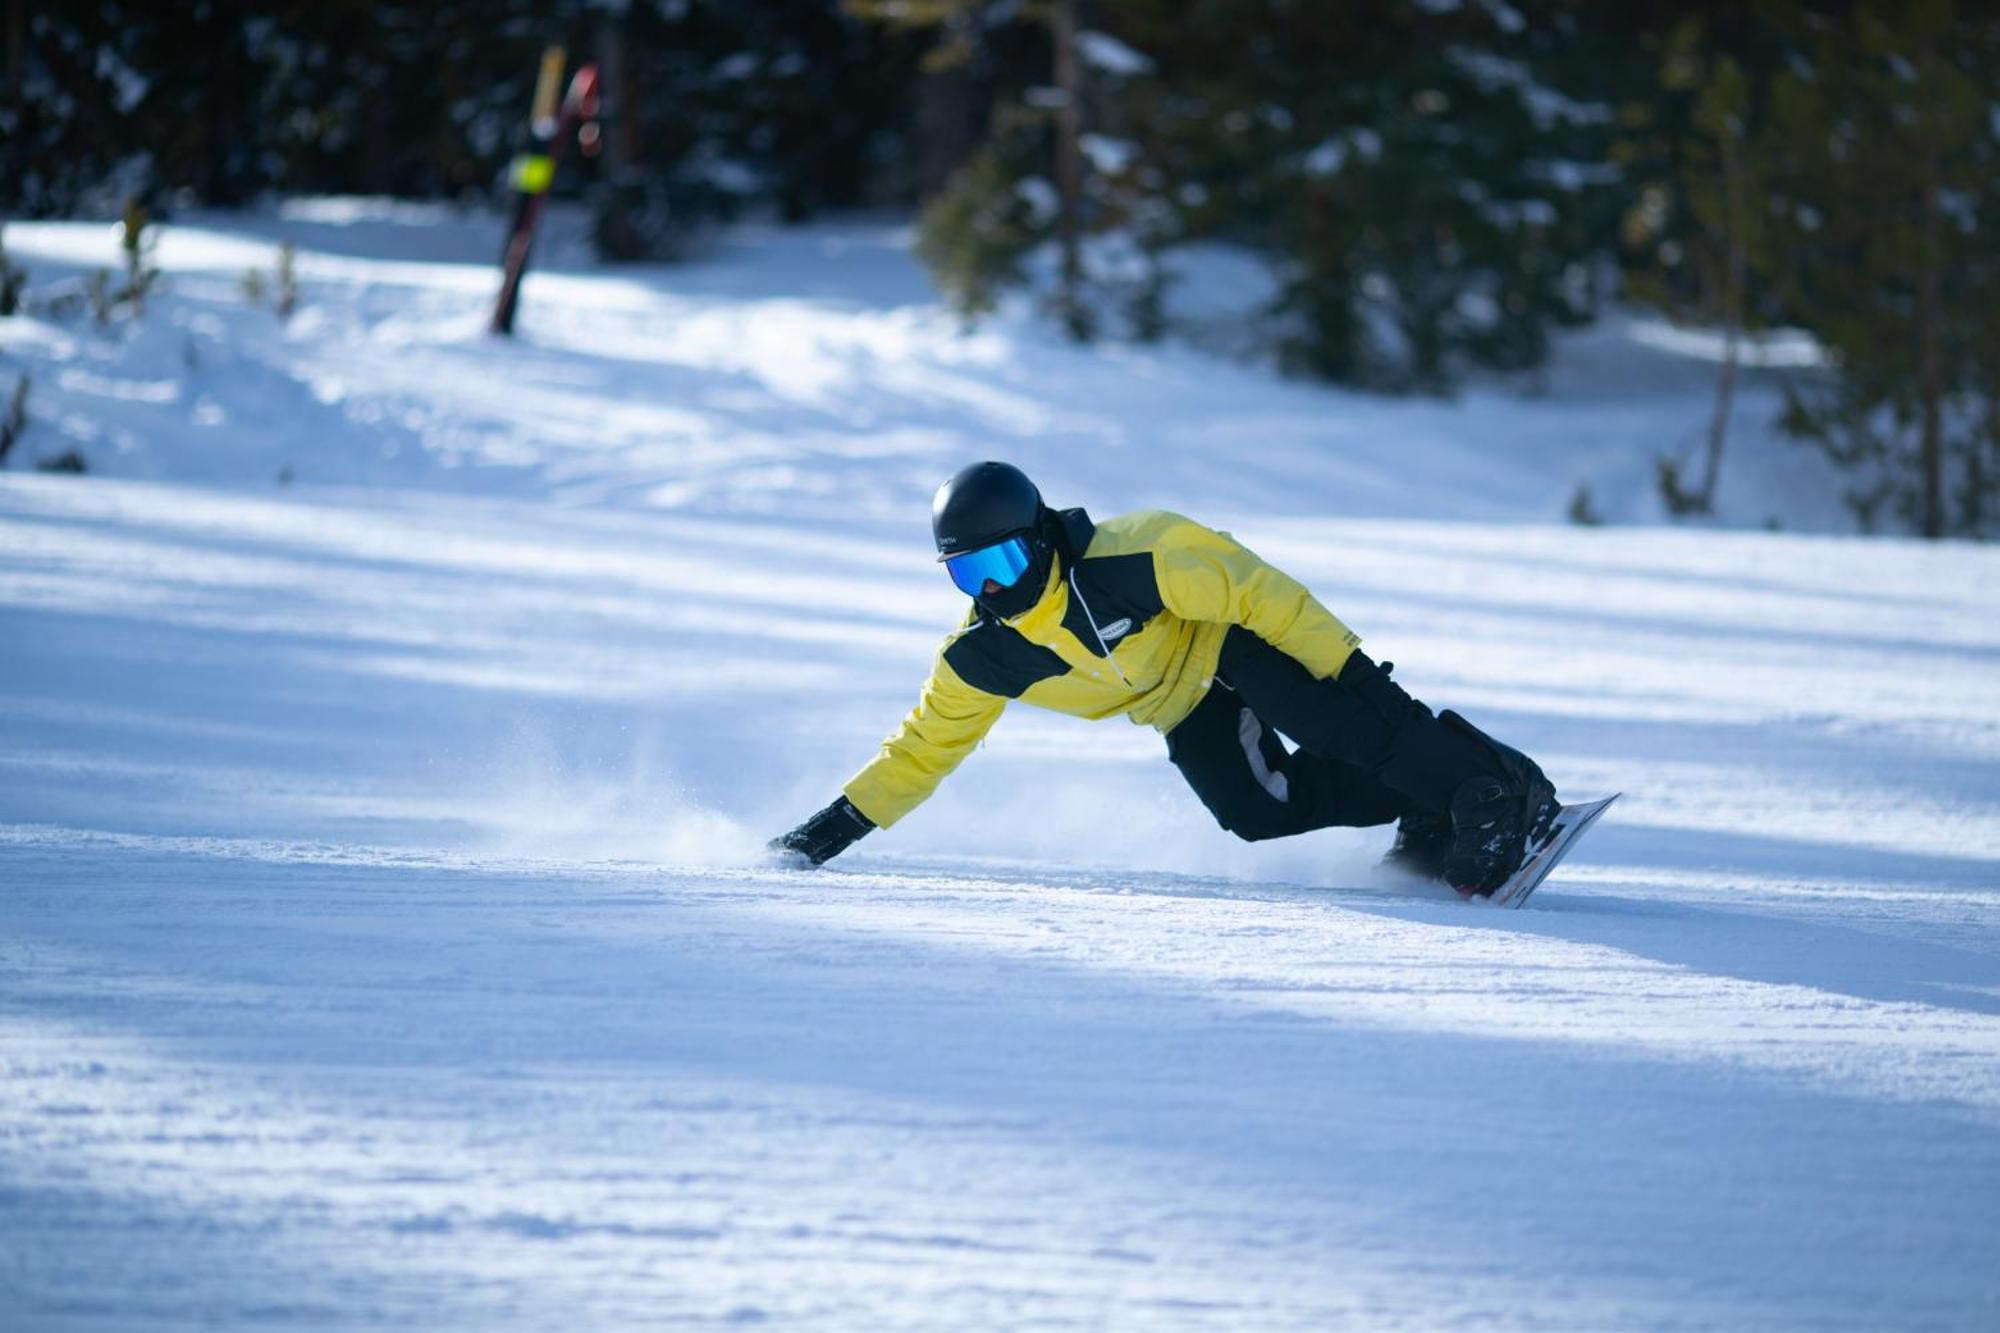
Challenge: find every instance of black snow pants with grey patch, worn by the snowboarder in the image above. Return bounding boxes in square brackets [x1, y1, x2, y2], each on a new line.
[1166, 626, 1410, 843]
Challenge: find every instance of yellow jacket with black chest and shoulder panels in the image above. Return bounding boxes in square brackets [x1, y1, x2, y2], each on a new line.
[842, 508, 1360, 829]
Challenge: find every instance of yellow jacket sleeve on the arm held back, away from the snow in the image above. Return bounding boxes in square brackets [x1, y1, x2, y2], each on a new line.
[1154, 520, 1362, 679]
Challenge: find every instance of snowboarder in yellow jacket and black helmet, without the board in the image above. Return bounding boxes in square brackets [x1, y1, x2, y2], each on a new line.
[772, 462, 1560, 895]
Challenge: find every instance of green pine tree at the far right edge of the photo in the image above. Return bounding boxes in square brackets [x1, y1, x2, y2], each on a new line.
[1774, 0, 2000, 536]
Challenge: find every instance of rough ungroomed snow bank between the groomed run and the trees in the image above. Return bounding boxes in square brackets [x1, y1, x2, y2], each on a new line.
[8, 212, 1852, 528]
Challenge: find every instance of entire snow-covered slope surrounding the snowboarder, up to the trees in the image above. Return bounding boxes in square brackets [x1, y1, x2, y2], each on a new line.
[0, 204, 2000, 1329]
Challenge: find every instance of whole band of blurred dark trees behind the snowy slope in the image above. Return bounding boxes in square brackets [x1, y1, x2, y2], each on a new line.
[11, 0, 2000, 534]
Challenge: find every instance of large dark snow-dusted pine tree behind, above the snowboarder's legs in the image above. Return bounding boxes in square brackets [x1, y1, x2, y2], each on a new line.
[1116, 0, 1620, 390]
